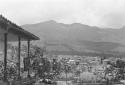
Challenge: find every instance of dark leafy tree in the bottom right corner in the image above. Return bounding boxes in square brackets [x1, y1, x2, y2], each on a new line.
[105, 59, 125, 81]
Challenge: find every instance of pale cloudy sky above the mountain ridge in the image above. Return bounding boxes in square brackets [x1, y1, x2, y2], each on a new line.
[0, 0, 125, 28]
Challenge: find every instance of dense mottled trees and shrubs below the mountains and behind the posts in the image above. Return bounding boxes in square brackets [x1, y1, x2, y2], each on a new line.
[0, 45, 125, 82]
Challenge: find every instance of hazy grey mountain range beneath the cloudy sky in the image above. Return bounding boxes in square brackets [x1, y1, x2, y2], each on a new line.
[22, 20, 125, 53]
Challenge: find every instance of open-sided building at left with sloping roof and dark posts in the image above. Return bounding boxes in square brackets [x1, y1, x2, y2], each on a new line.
[0, 15, 39, 81]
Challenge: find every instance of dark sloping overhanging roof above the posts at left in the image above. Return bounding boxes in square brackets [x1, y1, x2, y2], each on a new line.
[0, 15, 39, 40]
